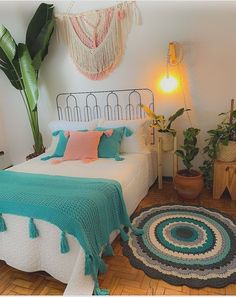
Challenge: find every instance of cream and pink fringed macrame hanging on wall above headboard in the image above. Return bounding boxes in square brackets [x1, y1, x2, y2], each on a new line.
[56, 1, 141, 80]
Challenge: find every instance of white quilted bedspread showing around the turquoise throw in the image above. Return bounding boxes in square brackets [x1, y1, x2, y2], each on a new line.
[0, 152, 157, 295]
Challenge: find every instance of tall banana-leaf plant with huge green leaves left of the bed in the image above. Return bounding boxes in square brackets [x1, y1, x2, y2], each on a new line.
[0, 3, 54, 155]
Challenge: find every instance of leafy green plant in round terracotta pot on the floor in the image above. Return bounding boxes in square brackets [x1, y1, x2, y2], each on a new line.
[174, 128, 204, 199]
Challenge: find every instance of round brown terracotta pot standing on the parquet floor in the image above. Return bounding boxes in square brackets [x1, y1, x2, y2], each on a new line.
[174, 170, 204, 199]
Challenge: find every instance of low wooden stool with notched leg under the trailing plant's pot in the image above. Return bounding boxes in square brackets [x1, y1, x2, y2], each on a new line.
[213, 161, 236, 200]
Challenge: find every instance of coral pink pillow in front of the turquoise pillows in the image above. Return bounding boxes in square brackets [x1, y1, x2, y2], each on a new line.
[62, 131, 103, 161]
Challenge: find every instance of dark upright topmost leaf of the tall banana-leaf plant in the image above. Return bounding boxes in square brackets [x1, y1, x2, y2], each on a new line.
[26, 3, 54, 71]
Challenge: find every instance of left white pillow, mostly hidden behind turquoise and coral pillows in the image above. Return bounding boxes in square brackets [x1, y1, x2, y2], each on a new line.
[46, 120, 98, 154]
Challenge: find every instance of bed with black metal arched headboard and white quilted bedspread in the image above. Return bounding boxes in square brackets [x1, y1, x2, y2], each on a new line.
[0, 89, 157, 295]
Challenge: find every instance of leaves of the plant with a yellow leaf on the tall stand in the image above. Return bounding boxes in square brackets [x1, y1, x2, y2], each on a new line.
[142, 105, 190, 136]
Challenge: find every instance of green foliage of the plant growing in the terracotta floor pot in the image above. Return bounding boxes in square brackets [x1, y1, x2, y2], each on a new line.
[175, 128, 200, 176]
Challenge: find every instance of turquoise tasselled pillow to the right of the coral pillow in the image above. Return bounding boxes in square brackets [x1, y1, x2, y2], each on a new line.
[96, 127, 133, 161]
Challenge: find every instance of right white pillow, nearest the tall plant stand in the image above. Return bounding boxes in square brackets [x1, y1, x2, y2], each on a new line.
[98, 119, 151, 153]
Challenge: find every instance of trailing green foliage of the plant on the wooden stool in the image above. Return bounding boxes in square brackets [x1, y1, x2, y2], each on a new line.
[200, 110, 236, 190]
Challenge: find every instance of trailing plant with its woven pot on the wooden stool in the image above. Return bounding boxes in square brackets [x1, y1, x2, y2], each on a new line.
[200, 104, 236, 189]
